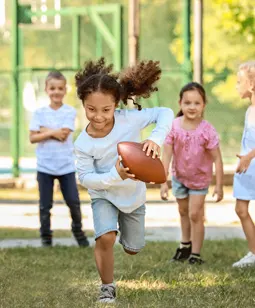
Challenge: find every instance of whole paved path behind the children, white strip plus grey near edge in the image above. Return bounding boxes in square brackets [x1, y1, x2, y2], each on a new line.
[0, 200, 255, 248]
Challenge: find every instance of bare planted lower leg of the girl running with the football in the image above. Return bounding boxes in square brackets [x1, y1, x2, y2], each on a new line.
[95, 232, 116, 284]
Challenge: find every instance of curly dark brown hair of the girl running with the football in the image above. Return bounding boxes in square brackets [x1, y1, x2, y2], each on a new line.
[75, 58, 161, 110]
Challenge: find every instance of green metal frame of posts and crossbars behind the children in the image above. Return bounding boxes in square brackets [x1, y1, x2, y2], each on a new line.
[0, 0, 192, 177]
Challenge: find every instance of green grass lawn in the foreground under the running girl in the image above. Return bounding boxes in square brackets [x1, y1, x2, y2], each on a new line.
[0, 240, 255, 308]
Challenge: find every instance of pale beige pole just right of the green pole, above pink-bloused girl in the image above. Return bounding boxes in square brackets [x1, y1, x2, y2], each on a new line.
[193, 0, 203, 84]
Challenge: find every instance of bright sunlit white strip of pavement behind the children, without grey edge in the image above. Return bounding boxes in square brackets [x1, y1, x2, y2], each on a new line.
[0, 201, 255, 230]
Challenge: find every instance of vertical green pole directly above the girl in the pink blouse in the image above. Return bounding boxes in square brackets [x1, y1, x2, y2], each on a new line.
[183, 0, 192, 83]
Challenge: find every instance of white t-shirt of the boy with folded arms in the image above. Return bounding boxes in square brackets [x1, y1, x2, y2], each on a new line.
[29, 104, 76, 176]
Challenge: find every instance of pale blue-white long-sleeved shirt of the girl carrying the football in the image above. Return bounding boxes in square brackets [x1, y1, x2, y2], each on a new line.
[74, 107, 174, 213]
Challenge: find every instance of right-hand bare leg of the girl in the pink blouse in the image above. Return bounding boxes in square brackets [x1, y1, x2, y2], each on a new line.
[189, 195, 205, 254]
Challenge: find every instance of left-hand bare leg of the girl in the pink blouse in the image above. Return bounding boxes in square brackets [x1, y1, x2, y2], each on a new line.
[176, 197, 190, 243]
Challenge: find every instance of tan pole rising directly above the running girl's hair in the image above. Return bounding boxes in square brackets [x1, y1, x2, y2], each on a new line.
[128, 0, 140, 65]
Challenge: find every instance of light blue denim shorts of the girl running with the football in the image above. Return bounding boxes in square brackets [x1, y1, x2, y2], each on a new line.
[92, 199, 145, 252]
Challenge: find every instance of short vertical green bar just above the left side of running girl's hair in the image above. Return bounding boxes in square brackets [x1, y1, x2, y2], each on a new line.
[72, 15, 81, 69]
